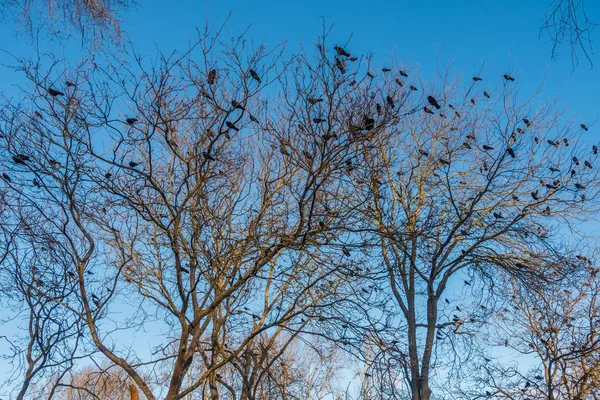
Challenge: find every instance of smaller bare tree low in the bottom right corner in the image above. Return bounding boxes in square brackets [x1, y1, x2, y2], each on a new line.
[472, 255, 600, 400]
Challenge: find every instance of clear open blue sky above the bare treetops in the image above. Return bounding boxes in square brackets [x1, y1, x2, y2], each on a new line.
[0, 0, 600, 394]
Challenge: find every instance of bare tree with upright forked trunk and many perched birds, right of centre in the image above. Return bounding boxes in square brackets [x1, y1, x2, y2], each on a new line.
[338, 66, 598, 400]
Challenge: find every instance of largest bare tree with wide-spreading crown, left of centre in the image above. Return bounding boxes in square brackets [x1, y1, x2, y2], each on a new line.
[0, 27, 404, 399]
